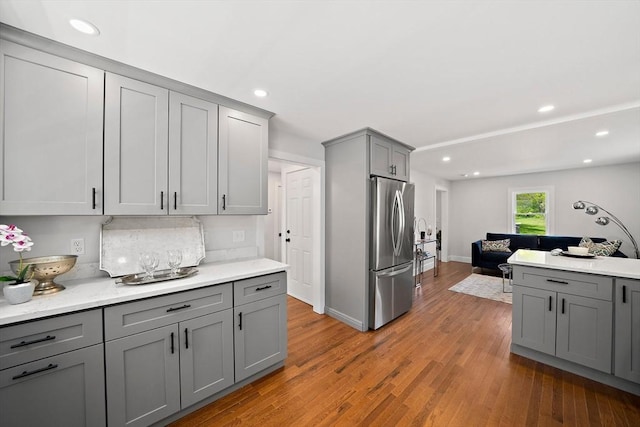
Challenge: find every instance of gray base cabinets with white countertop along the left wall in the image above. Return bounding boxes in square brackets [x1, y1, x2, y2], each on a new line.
[0, 259, 287, 427]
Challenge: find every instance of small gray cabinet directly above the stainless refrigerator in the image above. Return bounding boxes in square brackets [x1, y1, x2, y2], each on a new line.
[369, 135, 411, 181]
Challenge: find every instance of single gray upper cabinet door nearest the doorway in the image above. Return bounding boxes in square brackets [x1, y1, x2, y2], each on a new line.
[218, 106, 269, 215]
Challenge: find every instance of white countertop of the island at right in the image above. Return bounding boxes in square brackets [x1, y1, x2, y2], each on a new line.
[507, 249, 640, 279]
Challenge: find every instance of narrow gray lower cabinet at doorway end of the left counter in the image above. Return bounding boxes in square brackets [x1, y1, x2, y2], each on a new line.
[234, 273, 287, 381]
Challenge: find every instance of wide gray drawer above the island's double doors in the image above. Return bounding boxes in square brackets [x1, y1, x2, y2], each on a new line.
[513, 265, 613, 301]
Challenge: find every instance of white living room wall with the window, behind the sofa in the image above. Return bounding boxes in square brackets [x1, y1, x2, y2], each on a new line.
[449, 163, 640, 262]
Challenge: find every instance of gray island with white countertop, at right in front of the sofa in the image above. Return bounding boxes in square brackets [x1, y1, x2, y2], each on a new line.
[508, 249, 640, 395]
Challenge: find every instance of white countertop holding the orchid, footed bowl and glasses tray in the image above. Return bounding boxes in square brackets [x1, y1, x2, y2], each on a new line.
[0, 258, 288, 326]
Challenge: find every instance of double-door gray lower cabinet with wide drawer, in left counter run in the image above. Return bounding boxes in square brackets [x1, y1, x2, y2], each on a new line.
[104, 283, 234, 426]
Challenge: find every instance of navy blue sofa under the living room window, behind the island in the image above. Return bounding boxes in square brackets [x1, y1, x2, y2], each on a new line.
[471, 233, 627, 270]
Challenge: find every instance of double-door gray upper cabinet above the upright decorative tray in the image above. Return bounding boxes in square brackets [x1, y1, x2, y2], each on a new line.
[105, 73, 218, 215]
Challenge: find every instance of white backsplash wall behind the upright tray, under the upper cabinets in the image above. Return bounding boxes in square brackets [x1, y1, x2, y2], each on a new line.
[0, 215, 264, 280]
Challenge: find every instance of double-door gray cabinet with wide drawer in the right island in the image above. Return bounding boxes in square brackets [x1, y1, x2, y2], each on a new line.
[512, 266, 613, 374]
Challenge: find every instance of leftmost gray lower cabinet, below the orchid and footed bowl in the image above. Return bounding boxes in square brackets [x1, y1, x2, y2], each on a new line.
[0, 309, 106, 427]
